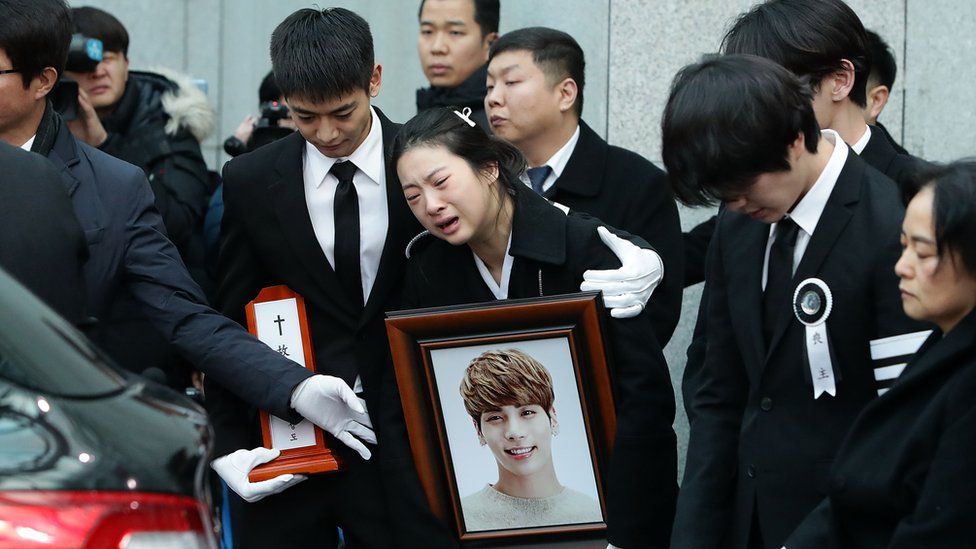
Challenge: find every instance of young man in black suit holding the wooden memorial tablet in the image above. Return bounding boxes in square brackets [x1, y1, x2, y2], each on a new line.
[207, 8, 649, 547]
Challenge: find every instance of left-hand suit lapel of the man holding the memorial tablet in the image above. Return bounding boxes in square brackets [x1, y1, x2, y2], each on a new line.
[268, 132, 358, 320]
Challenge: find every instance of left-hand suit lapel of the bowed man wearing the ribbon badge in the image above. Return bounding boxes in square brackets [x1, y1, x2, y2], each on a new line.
[719, 212, 769, 369]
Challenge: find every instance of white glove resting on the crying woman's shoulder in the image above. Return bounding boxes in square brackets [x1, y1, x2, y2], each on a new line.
[580, 227, 664, 318]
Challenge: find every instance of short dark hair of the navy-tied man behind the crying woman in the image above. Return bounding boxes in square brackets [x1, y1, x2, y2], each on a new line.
[488, 27, 586, 116]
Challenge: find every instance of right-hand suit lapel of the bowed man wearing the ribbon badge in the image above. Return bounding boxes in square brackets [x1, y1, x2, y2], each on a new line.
[766, 154, 864, 358]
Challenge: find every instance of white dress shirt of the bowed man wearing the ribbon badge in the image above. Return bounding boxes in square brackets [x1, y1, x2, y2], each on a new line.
[762, 130, 848, 290]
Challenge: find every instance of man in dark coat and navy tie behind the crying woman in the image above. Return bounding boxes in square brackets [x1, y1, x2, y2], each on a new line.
[485, 27, 683, 347]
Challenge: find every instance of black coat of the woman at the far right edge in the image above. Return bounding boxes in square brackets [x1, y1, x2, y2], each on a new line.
[786, 312, 976, 549]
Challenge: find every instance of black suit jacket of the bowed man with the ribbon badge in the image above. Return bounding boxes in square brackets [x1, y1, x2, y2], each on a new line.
[672, 154, 922, 548]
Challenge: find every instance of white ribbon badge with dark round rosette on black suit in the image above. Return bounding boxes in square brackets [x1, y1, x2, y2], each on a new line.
[793, 278, 837, 399]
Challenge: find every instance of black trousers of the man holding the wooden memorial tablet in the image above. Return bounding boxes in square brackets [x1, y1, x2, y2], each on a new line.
[230, 459, 398, 549]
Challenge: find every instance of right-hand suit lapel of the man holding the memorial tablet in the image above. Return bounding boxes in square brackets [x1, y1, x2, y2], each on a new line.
[360, 111, 421, 324]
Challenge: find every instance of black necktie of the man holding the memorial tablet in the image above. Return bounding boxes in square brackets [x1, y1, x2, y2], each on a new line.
[329, 161, 363, 308]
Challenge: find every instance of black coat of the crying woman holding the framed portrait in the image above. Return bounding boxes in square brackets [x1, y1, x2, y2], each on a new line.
[387, 189, 677, 547]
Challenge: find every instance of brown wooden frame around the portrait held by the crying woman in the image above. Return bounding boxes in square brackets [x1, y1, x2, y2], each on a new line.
[386, 292, 616, 544]
